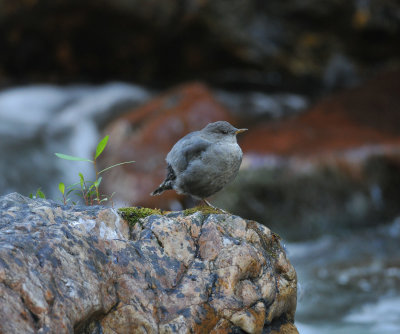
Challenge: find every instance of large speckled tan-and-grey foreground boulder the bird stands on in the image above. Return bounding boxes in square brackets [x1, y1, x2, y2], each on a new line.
[0, 193, 297, 333]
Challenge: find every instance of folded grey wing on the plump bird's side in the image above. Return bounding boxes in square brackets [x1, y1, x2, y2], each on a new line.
[167, 136, 211, 171]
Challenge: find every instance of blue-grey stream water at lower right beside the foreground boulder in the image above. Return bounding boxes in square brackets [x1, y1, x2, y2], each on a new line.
[287, 218, 400, 334]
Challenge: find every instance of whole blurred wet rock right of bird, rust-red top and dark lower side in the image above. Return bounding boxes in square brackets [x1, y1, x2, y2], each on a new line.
[214, 71, 400, 239]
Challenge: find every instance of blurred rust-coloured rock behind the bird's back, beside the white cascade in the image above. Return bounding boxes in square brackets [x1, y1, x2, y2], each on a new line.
[104, 83, 233, 209]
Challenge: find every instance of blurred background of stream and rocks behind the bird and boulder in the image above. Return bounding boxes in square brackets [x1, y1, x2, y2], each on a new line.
[0, 0, 400, 334]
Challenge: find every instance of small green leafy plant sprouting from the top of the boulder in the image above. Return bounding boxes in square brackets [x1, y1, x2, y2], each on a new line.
[55, 136, 134, 205]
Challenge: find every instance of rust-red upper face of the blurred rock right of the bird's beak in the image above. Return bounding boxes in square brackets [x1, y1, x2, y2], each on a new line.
[241, 71, 400, 157]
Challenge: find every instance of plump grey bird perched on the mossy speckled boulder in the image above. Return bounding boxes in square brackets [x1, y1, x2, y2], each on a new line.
[151, 121, 247, 206]
